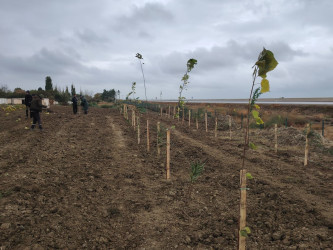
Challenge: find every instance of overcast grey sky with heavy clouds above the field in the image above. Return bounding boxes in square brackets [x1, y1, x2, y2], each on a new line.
[0, 0, 333, 99]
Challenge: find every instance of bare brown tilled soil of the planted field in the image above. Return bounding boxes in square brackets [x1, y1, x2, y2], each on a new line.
[0, 106, 333, 250]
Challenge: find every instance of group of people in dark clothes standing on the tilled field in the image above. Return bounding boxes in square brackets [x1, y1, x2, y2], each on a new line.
[24, 90, 89, 131]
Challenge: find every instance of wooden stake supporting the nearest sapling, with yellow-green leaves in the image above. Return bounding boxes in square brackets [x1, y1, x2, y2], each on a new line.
[238, 169, 246, 250]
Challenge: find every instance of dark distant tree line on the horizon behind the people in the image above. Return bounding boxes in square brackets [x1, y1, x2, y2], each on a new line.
[0, 76, 120, 104]
